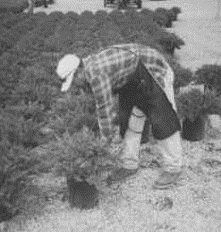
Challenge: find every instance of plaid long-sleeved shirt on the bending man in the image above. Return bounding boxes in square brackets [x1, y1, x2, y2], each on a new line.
[83, 44, 171, 138]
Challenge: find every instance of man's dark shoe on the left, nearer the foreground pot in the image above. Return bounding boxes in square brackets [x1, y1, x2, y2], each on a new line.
[107, 168, 138, 186]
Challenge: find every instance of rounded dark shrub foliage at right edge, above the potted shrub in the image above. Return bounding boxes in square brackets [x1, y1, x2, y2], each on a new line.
[195, 64, 221, 94]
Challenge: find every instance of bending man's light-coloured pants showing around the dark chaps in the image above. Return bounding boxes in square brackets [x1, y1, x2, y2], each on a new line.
[120, 65, 183, 172]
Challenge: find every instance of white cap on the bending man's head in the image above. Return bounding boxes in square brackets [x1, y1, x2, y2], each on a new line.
[56, 54, 80, 92]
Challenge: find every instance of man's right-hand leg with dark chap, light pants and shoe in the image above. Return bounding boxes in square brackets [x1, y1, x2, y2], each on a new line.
[134, 61, 183, 186]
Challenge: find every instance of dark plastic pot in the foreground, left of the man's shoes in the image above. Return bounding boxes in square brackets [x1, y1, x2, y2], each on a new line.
[67, 174, 99, 210]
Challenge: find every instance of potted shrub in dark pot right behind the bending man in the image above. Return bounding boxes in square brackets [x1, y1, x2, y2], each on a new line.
[176, 86, 221, 141]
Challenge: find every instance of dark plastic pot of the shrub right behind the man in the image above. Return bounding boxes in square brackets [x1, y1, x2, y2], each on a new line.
[182, 115, 207, 142]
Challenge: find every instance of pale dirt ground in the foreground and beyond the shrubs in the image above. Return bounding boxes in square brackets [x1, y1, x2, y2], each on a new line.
[4, 0, 221, 232]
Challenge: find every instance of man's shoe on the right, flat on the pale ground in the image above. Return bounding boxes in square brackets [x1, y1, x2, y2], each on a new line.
[153, 171, 183, 189]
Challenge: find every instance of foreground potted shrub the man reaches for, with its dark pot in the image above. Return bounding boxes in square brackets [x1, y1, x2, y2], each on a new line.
[49, 128, 116, 209]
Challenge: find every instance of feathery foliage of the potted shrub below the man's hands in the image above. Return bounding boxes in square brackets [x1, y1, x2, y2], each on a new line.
[44, 130, 115, 184]
